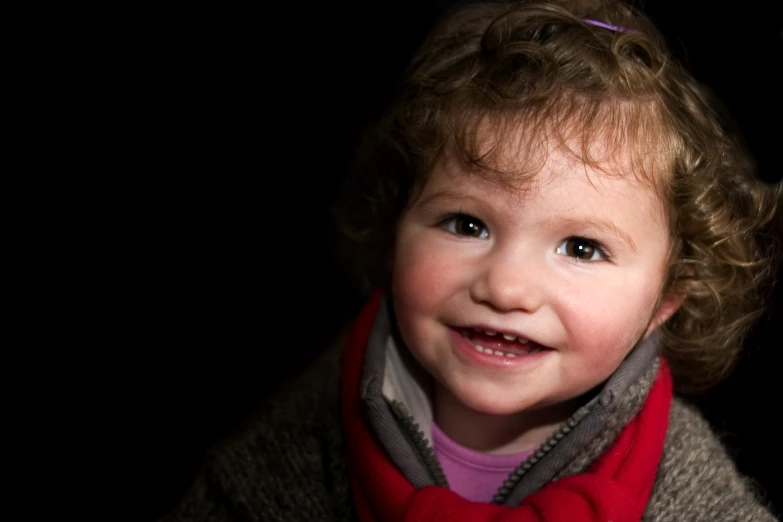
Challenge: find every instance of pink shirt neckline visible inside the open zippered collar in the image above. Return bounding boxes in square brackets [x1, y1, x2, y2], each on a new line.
[432, 423, 535, 502]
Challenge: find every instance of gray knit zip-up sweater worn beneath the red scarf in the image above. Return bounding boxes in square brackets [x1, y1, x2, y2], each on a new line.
[161, 306, 776, 522]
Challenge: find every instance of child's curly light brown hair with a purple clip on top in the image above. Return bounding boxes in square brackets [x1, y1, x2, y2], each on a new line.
[335, 0, 781, 391]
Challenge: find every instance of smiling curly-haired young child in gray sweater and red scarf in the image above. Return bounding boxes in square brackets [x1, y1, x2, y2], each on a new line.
[161, 0, 781, 522]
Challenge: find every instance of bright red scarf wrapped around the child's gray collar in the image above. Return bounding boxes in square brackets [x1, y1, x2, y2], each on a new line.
[341, 292, 672, 522]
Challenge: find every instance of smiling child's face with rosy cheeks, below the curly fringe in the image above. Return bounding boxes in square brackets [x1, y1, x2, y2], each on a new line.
[392, 132, 676, 415]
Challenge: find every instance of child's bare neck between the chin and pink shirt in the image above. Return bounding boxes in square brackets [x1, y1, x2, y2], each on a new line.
[434, 384, 581, 455]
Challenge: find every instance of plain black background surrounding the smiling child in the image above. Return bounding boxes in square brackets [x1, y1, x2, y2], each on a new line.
[10, 0, 783, 521]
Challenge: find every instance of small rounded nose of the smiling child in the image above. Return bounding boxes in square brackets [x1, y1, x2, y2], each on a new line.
[470, 251, 546, 313]
